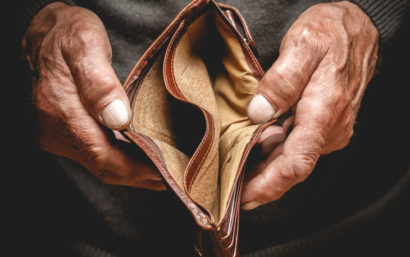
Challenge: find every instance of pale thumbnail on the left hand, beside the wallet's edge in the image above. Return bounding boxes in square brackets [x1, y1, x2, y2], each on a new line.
[101, 99, 130, 129]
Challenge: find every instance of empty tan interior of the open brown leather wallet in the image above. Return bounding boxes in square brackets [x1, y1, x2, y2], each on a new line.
[131, 8, 258, 224]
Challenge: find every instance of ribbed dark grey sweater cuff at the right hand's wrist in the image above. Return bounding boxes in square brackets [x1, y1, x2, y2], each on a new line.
[351, 0, 410, 44]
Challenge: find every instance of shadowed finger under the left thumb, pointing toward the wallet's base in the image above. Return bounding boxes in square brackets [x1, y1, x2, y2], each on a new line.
[38, 116, 165, 190]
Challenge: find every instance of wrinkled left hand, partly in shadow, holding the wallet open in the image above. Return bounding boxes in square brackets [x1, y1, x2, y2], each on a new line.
[23, 3, 165, 190]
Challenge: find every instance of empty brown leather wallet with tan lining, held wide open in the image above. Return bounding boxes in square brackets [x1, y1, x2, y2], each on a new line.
[122, 0, 278, 257]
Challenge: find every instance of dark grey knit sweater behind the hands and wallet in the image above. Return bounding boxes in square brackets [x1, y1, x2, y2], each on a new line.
[16, 0, 410, 257]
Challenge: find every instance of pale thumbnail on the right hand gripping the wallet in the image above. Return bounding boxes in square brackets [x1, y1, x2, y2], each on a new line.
[248, 94, 276, 124]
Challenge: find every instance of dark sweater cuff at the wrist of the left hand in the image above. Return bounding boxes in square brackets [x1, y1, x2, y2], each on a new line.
[19, 0, 75, 37]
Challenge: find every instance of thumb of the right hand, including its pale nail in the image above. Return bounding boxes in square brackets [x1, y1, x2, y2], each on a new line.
[248, 29, 326, 124]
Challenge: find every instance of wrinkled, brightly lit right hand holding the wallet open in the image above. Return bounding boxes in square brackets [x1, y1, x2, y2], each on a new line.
[242, 2, 379, 210]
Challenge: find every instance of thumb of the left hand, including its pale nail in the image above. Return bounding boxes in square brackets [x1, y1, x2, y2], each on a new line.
[63, 25, 131, 130]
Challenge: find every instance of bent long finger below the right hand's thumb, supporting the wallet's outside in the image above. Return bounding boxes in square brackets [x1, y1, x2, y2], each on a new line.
[242, 97, 325, 210]
